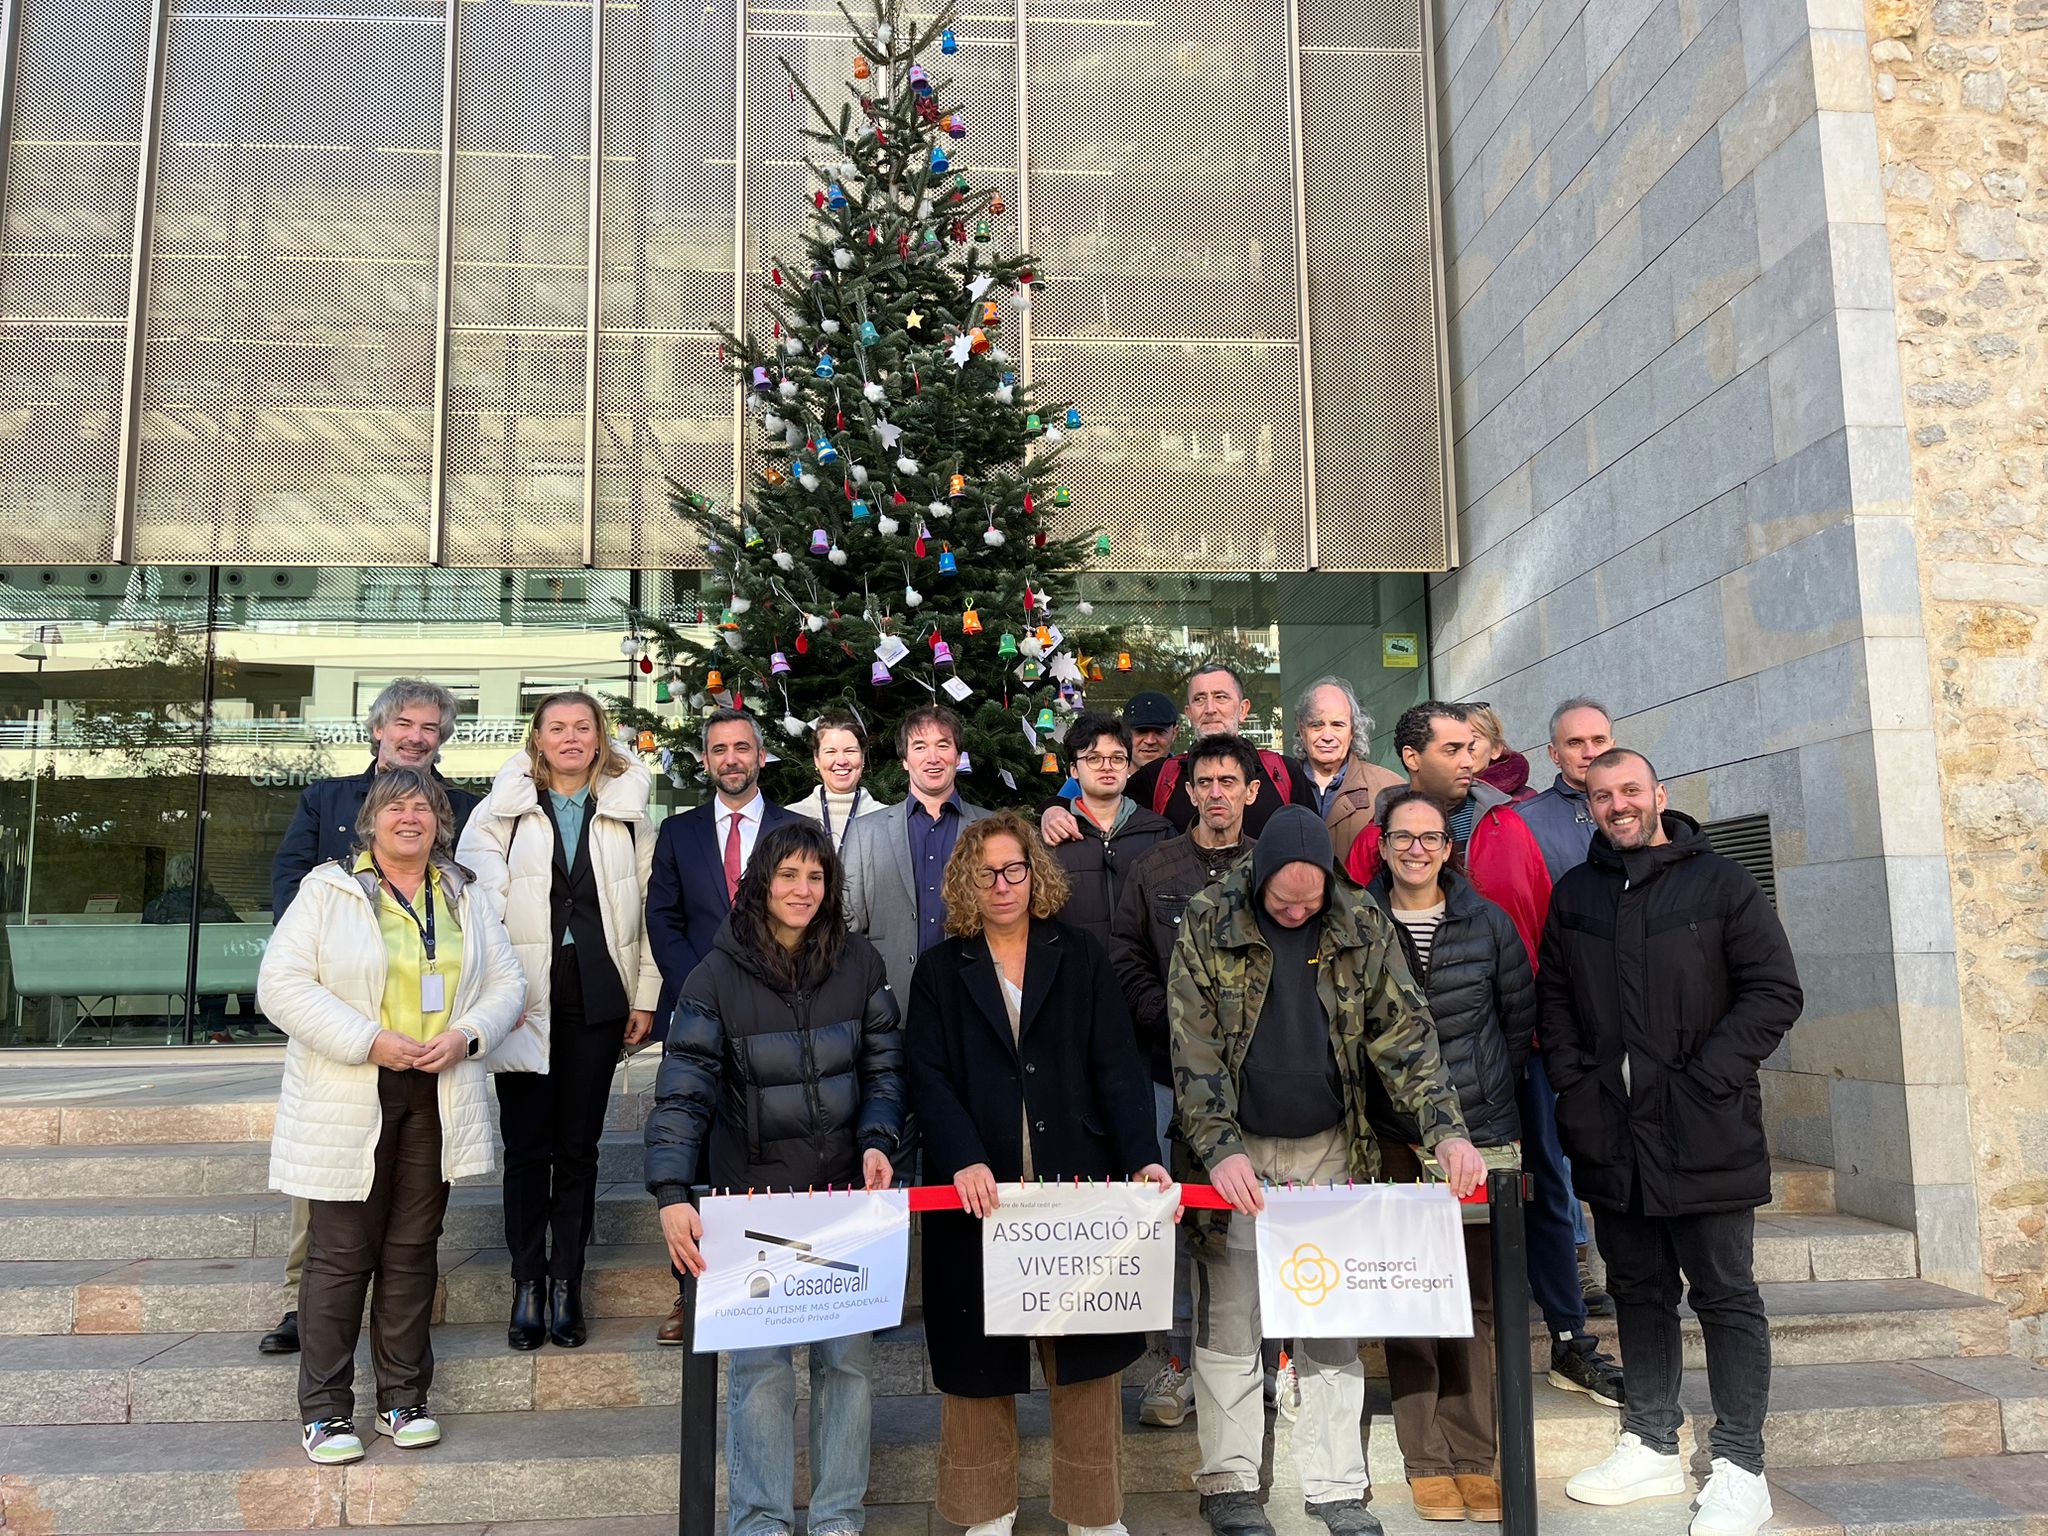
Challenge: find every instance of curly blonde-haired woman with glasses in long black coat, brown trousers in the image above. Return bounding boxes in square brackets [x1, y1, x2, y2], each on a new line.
[907, 811, 1171, 1536]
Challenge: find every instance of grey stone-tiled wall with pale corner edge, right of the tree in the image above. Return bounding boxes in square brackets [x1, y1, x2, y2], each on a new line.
[1432, 0, 1990, 1288]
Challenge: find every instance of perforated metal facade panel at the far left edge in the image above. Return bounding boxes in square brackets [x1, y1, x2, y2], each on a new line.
[0, 0, 150, 563]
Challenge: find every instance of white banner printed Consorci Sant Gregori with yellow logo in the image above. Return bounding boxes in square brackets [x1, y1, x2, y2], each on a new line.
[1233, 1184, 1473, 1339]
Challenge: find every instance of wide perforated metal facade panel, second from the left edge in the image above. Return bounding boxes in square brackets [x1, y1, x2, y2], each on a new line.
[135, 0, 444, 565]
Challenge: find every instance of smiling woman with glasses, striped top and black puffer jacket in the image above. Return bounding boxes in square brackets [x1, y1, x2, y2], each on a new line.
[1366, 788, 1536, 1522]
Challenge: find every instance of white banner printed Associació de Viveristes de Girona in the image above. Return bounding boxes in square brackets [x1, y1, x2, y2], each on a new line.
[981, 1184, 1180, 1337]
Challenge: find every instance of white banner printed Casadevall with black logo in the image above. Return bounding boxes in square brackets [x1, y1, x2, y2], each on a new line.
[696, 1190, 909, 1354]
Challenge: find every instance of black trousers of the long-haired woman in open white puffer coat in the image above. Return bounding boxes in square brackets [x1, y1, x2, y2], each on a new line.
[498, 946, 627, 1280]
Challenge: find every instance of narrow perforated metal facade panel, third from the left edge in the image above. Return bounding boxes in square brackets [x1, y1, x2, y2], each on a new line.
[442, 0, 590, 565]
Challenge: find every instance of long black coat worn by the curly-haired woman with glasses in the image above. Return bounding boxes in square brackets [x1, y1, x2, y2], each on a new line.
[905, 918, 1159, 1397]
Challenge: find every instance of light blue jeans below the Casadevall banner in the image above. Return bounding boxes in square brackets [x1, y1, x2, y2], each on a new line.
[725, 1333, 874, 1536]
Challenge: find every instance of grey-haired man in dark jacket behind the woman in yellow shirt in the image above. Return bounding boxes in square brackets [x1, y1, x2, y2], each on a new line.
[256, 678, 477, 1354]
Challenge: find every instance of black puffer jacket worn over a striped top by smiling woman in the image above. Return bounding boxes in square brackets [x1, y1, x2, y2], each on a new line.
[1366, 866, 1536, 1147]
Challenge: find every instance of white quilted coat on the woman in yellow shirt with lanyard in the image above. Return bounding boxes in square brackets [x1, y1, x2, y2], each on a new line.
[256, 862, 524, 1200]
